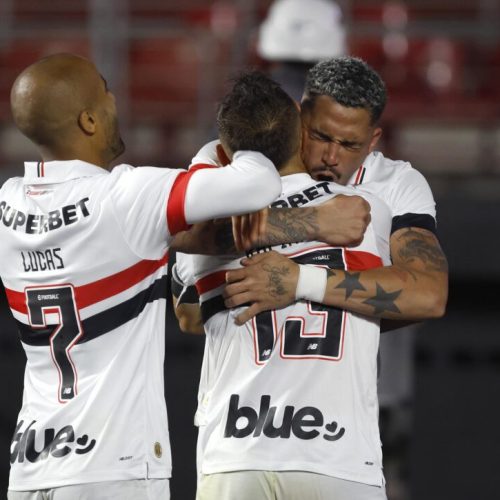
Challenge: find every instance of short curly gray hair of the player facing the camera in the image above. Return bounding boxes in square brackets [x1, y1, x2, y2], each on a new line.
[303, 56, 387, 124]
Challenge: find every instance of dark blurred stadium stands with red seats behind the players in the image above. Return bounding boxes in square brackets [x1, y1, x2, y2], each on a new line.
[0, 0, 500, 500]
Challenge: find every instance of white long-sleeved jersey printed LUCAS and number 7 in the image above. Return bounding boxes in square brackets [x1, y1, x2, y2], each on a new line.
[0, 153, 280, 490]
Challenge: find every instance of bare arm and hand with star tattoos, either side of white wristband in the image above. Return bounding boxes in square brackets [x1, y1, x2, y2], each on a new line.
[225, 228, 448, 323]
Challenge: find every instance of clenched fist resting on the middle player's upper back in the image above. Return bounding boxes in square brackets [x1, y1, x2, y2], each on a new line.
[317, 194, 371, 247]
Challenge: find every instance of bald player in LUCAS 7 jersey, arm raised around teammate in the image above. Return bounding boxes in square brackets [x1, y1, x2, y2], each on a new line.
[0, 54, 281, 500]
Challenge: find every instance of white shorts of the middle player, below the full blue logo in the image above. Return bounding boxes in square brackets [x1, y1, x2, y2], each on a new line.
[196, 470, 387, 500]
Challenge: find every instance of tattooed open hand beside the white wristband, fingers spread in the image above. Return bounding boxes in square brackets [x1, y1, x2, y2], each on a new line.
[223, 252, 299, 325]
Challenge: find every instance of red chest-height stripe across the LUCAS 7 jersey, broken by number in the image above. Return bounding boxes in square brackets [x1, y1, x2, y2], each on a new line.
[5, 253, 168, 314]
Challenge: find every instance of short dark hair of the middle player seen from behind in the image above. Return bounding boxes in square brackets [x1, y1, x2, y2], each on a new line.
[217, 71, 300, 169]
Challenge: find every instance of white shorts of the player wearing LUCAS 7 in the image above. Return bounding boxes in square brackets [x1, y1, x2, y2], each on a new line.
[7, 479, 170, 500]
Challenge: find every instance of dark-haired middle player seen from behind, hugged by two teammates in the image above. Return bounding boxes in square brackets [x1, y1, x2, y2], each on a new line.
[176, 73, 398, 500]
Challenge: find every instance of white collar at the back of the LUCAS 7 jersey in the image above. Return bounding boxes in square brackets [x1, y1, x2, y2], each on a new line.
[23, 160, 109, 184]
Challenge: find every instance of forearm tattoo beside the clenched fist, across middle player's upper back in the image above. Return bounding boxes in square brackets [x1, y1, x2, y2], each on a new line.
[261, 207, 319, 246]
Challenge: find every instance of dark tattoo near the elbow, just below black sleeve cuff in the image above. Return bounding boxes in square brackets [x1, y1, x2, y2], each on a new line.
[398, 228, 448, 273]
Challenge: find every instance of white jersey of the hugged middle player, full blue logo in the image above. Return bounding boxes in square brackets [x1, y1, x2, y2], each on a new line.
[177, 174, 391, 485]
